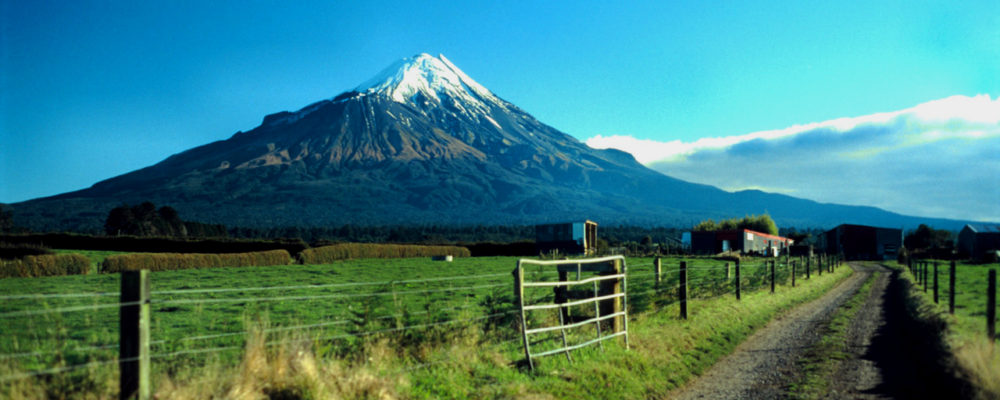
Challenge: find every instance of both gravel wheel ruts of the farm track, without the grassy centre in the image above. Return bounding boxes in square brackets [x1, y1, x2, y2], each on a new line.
[670, 264, 969, 399]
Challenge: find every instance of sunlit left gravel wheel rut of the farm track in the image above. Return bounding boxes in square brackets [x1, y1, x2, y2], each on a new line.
[670, 265, 872, 400]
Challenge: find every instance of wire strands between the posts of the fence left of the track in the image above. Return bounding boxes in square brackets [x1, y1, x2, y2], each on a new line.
[0, 261, 840, 382]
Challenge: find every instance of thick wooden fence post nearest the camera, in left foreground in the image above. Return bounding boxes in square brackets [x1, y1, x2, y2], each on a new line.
[118, 269, 151, 400]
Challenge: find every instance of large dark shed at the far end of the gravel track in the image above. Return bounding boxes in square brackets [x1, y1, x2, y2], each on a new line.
[826, 224, 903, 260]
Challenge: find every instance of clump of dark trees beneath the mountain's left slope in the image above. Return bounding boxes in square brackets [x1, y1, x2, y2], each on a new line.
[104, 201, 227, 237]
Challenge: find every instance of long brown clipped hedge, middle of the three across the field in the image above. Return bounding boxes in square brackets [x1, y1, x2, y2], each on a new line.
[101, 250, 292, 273]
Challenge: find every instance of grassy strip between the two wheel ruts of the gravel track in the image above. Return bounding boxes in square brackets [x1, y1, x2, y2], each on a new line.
[791, 264, 878, 399]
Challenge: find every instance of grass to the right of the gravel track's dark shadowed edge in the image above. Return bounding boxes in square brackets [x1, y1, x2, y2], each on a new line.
[897, 261, 1000, 399]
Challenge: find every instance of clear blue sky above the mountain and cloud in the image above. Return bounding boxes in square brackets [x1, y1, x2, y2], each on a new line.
[0, 0, 1000, 219]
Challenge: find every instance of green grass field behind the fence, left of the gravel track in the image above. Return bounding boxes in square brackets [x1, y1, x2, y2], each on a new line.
[0, 252, 846, 397]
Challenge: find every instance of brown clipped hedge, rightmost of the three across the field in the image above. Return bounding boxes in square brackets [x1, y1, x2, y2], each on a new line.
[299, 243, 469, 264]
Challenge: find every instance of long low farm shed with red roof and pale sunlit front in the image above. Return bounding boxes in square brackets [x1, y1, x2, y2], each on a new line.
[691, 229, 794, 256]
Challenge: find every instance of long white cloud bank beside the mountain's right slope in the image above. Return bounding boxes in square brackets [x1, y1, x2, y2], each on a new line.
[586, 95, 1000, 221]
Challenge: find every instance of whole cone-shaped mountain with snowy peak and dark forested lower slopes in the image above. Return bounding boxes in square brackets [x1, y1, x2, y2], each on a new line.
[12, 54, 976, 231]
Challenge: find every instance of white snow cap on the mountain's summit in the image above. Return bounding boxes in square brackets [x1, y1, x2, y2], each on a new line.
[355, 53, 497, 105]
